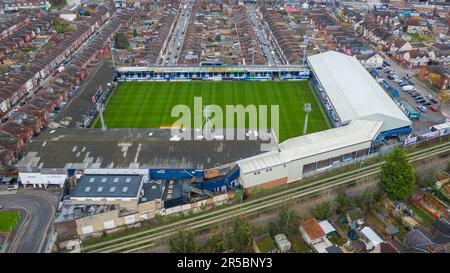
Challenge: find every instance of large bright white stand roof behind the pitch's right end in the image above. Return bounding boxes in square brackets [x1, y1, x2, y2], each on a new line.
[308, 51, 411, 132]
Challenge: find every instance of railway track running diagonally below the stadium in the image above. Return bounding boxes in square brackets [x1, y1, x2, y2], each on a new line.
[84, 141, 450, 253]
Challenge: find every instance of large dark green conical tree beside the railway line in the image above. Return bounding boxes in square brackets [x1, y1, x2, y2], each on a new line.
[380, 147, 416, 201]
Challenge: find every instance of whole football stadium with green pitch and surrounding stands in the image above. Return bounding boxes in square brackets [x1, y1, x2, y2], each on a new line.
[18, 51, 412, 196]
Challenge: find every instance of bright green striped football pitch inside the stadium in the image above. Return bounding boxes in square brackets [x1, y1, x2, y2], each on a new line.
[94, 81, 329, 141]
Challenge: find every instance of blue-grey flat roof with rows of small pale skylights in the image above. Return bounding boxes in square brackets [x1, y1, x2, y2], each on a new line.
[71, 174, 143, 198]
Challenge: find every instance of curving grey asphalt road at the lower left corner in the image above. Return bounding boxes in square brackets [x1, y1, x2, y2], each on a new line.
[0, 189, 60, 253]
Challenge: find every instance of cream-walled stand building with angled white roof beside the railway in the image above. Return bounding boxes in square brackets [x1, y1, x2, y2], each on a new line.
[237, 119, 383, 189]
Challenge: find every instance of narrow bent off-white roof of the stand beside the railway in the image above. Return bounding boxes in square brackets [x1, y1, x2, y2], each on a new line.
[238, 119, 383, 173]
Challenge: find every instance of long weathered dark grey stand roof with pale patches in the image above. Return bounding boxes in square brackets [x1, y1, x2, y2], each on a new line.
[17, 128, 276, 170]
